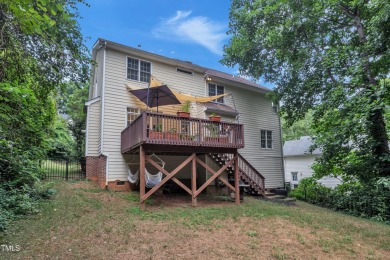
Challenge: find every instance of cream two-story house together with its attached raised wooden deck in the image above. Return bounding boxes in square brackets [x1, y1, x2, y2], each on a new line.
[85, 39, 284, 206]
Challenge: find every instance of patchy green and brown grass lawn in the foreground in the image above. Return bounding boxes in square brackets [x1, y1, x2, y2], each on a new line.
[0, 181, 390, 259]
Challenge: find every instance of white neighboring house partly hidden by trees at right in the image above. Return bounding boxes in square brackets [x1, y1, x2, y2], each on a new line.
[283, 136, 341, 188]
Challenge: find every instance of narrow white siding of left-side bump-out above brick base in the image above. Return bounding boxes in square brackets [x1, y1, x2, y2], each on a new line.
[86, 101, 100, 156]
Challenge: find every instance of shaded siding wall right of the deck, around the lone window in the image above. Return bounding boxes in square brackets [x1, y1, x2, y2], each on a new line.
[225, 84, 284, 189]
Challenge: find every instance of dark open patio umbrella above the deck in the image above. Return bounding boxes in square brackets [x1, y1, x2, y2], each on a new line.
[129, 85, 181, 112]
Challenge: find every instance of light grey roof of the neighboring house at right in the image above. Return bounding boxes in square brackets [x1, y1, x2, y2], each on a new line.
[283, 136, 321, 157]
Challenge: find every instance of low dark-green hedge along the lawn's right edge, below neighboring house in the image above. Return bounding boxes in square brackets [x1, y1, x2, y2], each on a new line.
[289, 177, 390, 223]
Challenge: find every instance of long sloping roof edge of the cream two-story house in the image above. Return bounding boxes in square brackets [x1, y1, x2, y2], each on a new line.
[92, 38, 272, 93]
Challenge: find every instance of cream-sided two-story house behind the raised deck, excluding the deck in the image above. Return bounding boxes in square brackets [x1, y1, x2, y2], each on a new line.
[86, 39, 284, 193]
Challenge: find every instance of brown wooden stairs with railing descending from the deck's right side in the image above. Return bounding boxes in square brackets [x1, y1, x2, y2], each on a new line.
[209, 153, 265, 196]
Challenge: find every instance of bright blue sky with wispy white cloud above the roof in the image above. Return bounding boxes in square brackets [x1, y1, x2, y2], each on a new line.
[79, 0, 272, 87]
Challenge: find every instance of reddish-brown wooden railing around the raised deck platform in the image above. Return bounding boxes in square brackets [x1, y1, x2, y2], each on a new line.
[121, 112, 244, 153]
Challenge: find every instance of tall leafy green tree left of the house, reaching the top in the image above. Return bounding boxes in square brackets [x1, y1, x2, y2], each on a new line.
[0, 0, 89, 185]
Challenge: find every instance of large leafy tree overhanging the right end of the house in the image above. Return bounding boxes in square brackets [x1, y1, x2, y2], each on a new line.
[222, 0, 390, 181]
